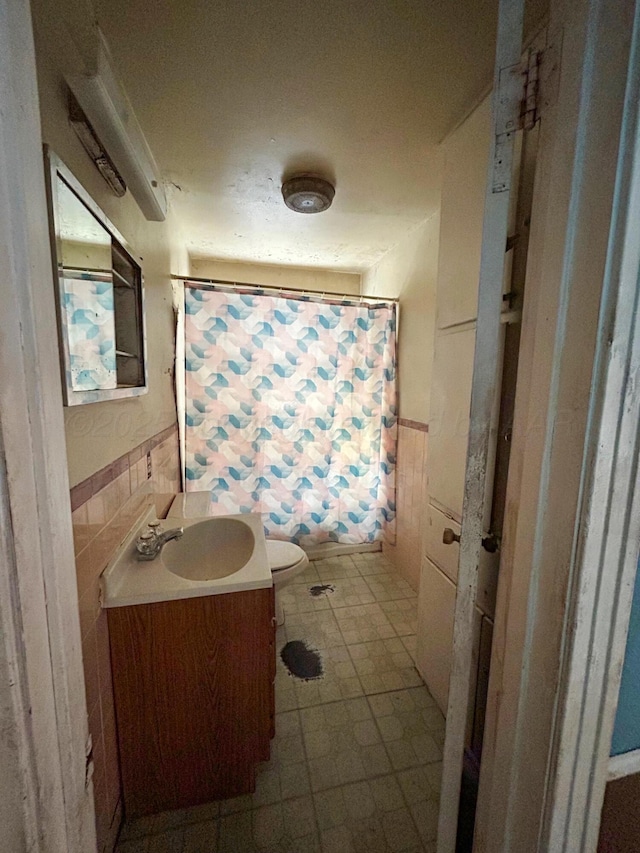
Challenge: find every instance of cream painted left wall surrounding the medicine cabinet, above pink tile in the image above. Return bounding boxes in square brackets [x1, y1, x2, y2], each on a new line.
[36, 40, 188, 486]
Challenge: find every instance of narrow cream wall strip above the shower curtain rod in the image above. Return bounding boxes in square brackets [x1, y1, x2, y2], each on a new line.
[190, 258, 360, 294]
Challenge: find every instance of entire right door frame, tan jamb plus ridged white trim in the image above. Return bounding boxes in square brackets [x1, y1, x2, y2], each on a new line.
[474, 0, 640, 853]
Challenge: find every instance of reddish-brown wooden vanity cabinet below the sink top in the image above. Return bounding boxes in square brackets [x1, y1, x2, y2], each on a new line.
[108, 589, 275, 817]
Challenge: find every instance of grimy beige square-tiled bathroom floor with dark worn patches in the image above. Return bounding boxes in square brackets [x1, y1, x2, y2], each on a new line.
[117, 553, 444, 853]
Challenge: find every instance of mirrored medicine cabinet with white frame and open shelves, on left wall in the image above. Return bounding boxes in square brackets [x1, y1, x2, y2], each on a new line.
[46, 151, 147, 406]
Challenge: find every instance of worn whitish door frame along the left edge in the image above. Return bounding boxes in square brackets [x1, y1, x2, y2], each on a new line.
[0, 0, 96, 853]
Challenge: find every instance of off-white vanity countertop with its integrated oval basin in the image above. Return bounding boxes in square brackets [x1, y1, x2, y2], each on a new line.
[100, 508, 273, 607]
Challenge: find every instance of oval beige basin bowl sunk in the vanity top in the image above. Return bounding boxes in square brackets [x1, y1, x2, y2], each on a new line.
[161, 518, 255, 581]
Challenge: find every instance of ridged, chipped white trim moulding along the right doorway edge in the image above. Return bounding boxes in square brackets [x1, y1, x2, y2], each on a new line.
[541, 4, 640, 851]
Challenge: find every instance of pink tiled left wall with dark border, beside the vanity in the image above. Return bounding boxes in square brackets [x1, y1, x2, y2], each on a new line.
[71, 425, 181, 853]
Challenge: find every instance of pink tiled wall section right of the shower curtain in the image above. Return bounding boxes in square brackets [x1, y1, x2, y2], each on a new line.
[382, 418, 428, 591]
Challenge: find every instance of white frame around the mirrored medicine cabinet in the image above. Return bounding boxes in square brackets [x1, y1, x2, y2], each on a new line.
[44, 145, 149, 406]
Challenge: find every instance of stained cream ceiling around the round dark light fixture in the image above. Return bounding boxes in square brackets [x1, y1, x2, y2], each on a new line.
[96, 0, 535, 272]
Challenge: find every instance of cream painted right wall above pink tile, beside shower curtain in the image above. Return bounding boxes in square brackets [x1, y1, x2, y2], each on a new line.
[362, 213, 440, 424]
